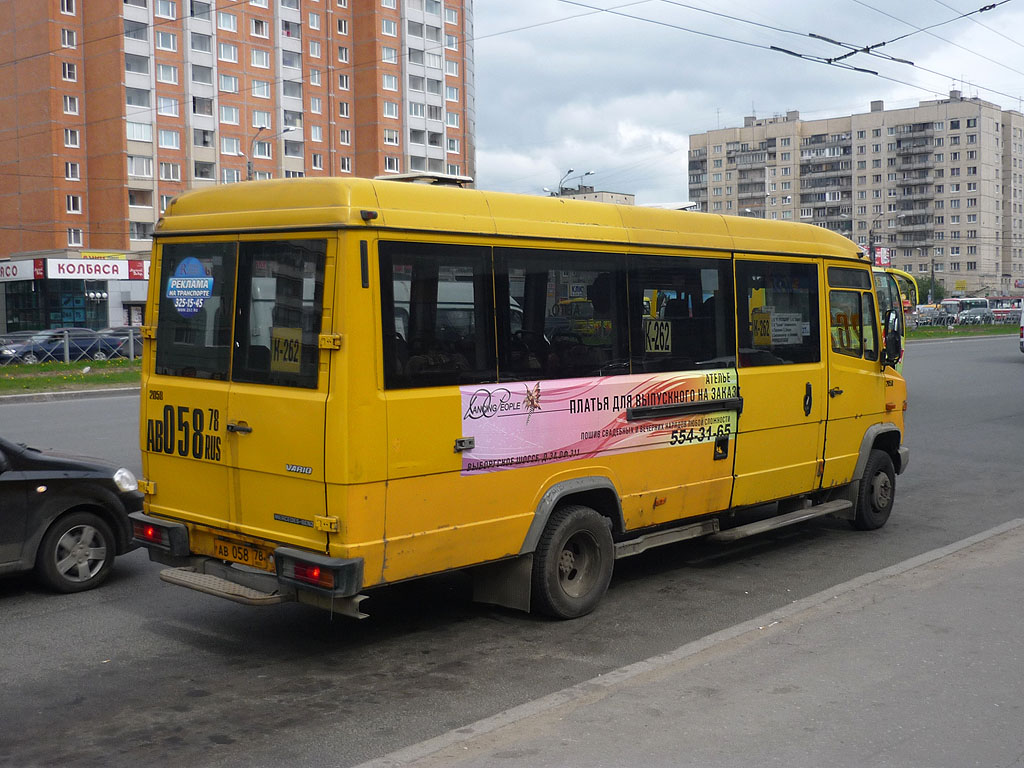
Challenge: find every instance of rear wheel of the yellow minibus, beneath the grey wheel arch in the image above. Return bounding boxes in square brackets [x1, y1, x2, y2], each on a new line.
[530, 505, 614, 618]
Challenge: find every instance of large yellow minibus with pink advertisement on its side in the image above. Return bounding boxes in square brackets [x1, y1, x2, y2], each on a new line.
[133, 178, 908, 618]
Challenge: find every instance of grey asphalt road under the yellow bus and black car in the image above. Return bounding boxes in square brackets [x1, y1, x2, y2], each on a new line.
[0, 337, 1024, 767]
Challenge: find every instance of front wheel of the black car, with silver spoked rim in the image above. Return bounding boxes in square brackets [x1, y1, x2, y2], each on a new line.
[36, 512, 117, 592]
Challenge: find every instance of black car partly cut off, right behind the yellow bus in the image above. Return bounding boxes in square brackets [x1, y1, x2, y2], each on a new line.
[0, 438, 142, 592]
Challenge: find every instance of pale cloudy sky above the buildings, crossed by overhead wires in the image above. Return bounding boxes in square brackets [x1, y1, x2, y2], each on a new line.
[474, 0, 1024, 204]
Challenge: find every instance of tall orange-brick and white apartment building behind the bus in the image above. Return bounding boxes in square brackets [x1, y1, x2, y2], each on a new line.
[0, 0, 475, 268]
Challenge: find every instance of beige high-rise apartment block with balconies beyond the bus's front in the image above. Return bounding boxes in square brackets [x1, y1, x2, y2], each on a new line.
[689, 90, 1024, 295]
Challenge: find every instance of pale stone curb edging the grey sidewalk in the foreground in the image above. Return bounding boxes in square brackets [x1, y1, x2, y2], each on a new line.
[356, 518, 1024, 768]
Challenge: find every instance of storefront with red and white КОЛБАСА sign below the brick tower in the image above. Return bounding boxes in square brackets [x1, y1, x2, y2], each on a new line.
[0, 258, 150, 332]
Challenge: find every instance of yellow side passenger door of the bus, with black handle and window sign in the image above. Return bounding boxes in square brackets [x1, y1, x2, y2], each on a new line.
[732, 256, 827, 507]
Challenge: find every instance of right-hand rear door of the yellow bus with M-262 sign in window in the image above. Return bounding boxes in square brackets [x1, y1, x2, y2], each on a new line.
[222, 238, 333, 552]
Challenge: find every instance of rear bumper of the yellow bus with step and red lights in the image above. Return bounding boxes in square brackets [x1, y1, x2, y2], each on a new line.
[129, 512, 362, 605]
